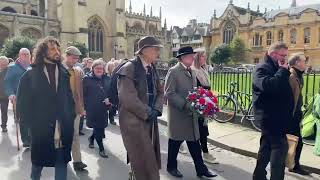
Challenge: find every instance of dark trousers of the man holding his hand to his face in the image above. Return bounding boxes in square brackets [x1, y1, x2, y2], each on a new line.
[253, 134, 288, 180]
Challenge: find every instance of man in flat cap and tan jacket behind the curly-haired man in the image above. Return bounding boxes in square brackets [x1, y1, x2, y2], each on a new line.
[63, 46, 87, 171]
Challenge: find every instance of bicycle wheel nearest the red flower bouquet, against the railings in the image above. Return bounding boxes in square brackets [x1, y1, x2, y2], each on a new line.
[214, 95, 237, 123]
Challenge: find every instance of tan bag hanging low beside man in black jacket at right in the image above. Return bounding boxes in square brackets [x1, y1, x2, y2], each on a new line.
[286, 134, 299, 169]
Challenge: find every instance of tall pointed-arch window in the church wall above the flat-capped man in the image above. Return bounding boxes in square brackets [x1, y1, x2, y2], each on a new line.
[88, 19, 104, 52]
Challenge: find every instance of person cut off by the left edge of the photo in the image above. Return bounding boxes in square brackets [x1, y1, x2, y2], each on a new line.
[0, 56, 9, 133]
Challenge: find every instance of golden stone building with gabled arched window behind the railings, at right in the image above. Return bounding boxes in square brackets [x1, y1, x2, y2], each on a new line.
[209, 0, 320, 69]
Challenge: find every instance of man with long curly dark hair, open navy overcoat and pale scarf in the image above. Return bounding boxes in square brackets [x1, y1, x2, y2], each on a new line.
[17, 37, 76, 180]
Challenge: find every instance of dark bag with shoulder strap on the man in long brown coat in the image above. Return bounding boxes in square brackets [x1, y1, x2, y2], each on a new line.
[109, 60, 137, 107]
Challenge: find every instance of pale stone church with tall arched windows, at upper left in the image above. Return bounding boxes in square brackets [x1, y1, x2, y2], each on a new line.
[0, 0, 170, 60]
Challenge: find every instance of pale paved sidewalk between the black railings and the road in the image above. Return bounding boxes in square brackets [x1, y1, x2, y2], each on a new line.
[159, 107, 320, 174]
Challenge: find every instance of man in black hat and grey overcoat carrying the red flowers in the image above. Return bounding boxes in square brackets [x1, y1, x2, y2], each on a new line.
[165, 46, 217, 178]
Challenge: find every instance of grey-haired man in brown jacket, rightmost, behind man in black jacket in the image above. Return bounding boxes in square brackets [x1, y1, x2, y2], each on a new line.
[288, 52, 310, 175]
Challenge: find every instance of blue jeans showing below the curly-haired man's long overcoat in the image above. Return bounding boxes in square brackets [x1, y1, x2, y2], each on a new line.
[31, 149, 67, 180]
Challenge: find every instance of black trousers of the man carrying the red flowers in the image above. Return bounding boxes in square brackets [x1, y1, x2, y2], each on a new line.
[167, 139, 208, 174]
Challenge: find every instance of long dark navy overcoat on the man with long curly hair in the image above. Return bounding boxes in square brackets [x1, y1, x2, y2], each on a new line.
[17, 64, 75, 167]
